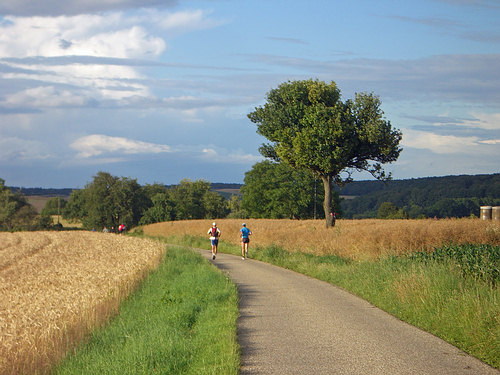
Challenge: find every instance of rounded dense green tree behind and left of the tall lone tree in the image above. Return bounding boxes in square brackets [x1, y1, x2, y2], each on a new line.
[241, 160, 339, 219]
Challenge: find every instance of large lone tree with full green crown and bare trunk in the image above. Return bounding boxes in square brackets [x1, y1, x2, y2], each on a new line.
[248, 80, 401, 227]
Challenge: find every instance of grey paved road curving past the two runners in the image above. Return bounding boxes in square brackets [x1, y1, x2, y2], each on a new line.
[193, 250, 500, 375]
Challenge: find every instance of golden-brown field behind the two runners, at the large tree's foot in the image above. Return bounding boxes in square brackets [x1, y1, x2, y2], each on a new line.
[143, 218, 500, 260]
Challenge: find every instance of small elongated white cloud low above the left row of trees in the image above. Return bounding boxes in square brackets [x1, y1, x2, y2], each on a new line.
[70, 134, 172, 158]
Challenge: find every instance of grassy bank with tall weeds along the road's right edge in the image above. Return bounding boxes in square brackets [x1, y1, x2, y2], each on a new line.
[169, 236, 500, 368]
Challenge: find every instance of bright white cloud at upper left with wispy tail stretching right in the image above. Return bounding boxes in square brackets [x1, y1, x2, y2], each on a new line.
[0, 9, 222, 58]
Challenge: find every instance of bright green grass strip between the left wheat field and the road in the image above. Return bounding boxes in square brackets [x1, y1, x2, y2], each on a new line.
[54, 247, 240, 375]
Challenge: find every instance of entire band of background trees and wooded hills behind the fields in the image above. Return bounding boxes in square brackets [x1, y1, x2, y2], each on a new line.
[0, 170, 500, 231]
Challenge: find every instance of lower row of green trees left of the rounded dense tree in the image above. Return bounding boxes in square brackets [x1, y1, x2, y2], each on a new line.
[63, 172, 229, 228]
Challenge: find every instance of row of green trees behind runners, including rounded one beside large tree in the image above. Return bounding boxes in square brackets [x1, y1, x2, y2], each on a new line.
[59, 161, 340, 228]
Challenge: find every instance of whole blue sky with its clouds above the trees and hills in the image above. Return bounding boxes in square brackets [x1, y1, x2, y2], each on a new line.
[0, 0, 500, 187]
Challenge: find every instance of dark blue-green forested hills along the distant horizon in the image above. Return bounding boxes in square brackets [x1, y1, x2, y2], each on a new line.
[11, 173, 500, 219]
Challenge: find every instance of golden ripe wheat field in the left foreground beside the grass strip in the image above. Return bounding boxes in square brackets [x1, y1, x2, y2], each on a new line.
[0, 231, 165, 375]
